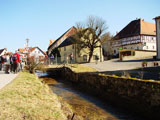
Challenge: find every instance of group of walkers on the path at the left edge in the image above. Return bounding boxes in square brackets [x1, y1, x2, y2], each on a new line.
[0, 52, 22, 74]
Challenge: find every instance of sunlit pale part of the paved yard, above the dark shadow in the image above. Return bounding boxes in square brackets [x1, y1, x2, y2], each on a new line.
[84, 59, 160, 72]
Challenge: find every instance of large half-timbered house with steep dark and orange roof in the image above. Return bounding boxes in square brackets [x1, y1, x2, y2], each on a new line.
[111, 19, 157, 56]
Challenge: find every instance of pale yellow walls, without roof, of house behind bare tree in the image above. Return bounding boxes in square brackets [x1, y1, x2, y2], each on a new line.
[59, 45, 103, 63]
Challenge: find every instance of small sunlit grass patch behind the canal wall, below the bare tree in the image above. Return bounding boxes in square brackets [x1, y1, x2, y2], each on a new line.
[49, 64, 98, 73]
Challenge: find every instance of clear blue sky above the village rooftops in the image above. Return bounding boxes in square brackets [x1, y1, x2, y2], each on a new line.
[0, 0, 160, 52]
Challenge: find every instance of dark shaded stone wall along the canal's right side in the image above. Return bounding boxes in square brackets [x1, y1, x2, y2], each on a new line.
[49, 68, 160, 120]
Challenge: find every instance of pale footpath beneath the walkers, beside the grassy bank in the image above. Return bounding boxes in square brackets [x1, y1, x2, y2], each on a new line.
[0, 71, 18, 89]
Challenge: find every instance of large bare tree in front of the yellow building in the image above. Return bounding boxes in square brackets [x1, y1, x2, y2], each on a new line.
[74, 16, 107, 62]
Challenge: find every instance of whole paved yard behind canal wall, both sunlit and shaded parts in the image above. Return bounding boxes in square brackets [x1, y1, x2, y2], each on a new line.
[84, 59, 160, 80]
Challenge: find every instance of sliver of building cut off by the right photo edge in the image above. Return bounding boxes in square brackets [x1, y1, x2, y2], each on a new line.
[154, 16, 160, 59]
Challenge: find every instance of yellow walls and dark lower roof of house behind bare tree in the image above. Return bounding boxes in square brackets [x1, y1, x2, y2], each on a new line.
[58, 39, 103, 63]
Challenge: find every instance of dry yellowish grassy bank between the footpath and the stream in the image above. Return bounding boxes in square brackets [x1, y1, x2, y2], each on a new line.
[0, 72, 73, 120]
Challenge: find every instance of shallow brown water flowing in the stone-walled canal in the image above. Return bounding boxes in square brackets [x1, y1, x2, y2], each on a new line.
[37, 72, 143, 120]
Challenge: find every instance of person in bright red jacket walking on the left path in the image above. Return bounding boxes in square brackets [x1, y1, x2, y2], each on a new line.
[12, 51, 20, 73]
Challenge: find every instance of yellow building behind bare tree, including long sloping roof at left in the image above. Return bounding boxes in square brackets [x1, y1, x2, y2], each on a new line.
[48, 27, 103, 63]
